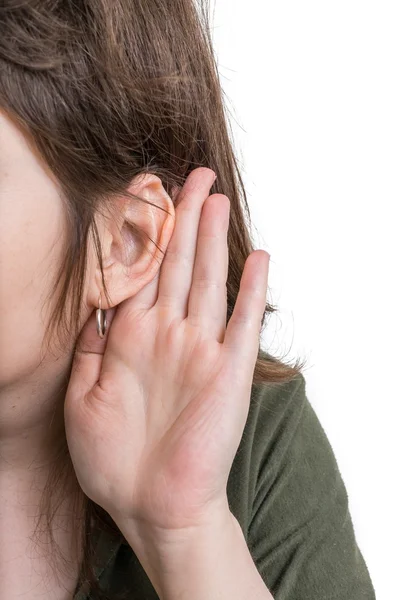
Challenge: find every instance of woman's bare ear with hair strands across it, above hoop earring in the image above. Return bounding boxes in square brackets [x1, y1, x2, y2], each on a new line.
[87, 173, 178, 309]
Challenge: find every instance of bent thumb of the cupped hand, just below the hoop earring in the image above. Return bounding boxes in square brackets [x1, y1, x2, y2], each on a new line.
[68, 307, 117, 398]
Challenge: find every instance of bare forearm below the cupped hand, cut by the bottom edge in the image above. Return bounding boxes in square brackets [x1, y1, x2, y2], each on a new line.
[116, 512, 273, 600]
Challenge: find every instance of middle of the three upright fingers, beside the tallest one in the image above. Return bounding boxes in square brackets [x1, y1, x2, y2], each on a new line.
[187, 194, 230, 343]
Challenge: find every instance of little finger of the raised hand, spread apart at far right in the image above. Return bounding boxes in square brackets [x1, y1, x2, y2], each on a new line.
[223, 250, 270, 373]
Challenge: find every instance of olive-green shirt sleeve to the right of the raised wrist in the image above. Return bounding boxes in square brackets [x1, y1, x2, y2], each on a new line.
[247, 374, 375, 600]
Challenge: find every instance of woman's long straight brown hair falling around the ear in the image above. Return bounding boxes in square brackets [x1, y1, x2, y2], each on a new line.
[0, 0, 305, 599]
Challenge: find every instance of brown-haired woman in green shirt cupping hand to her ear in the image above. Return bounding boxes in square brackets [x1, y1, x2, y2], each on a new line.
[0, 0, 374, 600]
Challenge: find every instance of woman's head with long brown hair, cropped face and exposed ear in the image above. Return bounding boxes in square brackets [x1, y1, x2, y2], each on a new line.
[0, 0, 303, 596]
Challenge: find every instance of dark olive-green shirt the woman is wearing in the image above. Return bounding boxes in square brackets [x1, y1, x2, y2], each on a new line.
[74, 364, 375, 600]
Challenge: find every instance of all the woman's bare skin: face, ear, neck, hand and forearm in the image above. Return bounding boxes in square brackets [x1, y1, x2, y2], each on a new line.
[0, 108, 272, 600]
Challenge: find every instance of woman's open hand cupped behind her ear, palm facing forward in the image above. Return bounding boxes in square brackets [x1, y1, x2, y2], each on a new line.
[64, 168, 269, 530]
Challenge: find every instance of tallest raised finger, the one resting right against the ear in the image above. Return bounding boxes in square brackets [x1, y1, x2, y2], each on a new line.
[157, 168, 215, 318]
